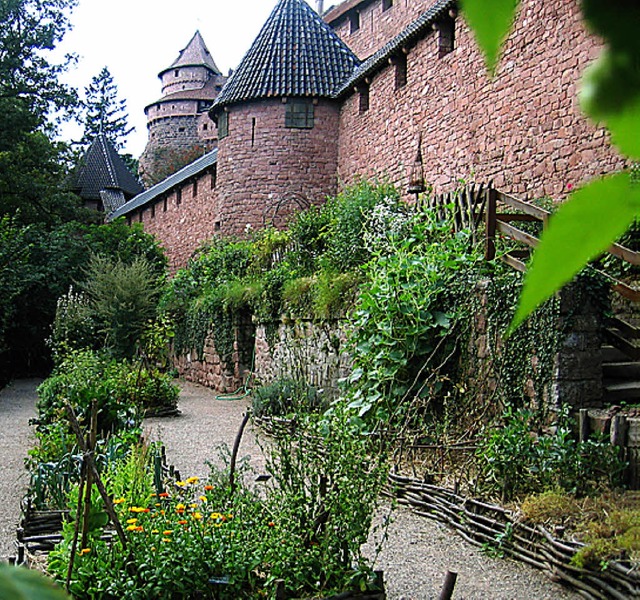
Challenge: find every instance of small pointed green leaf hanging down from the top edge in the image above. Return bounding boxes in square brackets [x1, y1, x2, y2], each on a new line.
[462, 0, 519, 74]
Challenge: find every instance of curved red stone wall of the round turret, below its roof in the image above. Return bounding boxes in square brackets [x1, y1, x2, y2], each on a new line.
[217, 99, 339, 235]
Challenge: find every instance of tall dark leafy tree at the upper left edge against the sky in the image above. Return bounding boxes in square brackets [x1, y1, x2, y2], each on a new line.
[0, 0, 82, 223]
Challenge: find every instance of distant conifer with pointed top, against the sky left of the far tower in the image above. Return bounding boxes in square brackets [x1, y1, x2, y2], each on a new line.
[83, 67, 134, 150]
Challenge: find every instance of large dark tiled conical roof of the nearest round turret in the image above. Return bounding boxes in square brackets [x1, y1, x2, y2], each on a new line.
[213, 0, 359, 110]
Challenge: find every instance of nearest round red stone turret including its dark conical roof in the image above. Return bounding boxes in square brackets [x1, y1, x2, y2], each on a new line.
[209, 0, 359, 234]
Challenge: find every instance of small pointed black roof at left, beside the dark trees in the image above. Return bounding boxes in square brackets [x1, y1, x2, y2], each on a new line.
[69, 133, 144, 206]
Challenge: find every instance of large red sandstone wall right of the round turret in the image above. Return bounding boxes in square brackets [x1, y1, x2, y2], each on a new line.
[338, 0, 625, 199]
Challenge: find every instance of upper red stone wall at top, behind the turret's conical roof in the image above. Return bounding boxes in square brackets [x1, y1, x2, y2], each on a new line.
[327, 0, 434, 59]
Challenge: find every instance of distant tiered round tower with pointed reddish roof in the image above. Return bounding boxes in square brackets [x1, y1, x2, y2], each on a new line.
[140, 31, 227, 186]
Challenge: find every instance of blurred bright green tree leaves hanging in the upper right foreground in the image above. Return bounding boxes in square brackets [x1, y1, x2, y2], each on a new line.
[462, 0, 640, 328]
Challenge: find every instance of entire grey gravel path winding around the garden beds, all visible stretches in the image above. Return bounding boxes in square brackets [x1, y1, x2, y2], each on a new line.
[0, 381, 580, 600]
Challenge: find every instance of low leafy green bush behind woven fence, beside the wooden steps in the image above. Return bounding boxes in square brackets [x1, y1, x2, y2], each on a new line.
[477, 409, 625, 501]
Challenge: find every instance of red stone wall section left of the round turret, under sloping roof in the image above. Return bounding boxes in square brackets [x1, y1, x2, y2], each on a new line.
[132, 173, 220, 273]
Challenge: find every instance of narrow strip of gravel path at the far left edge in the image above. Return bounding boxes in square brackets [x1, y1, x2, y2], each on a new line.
[0, 379, 40, 560]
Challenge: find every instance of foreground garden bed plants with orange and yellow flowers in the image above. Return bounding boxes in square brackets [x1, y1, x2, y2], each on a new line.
[48, 406, 386, 599]
